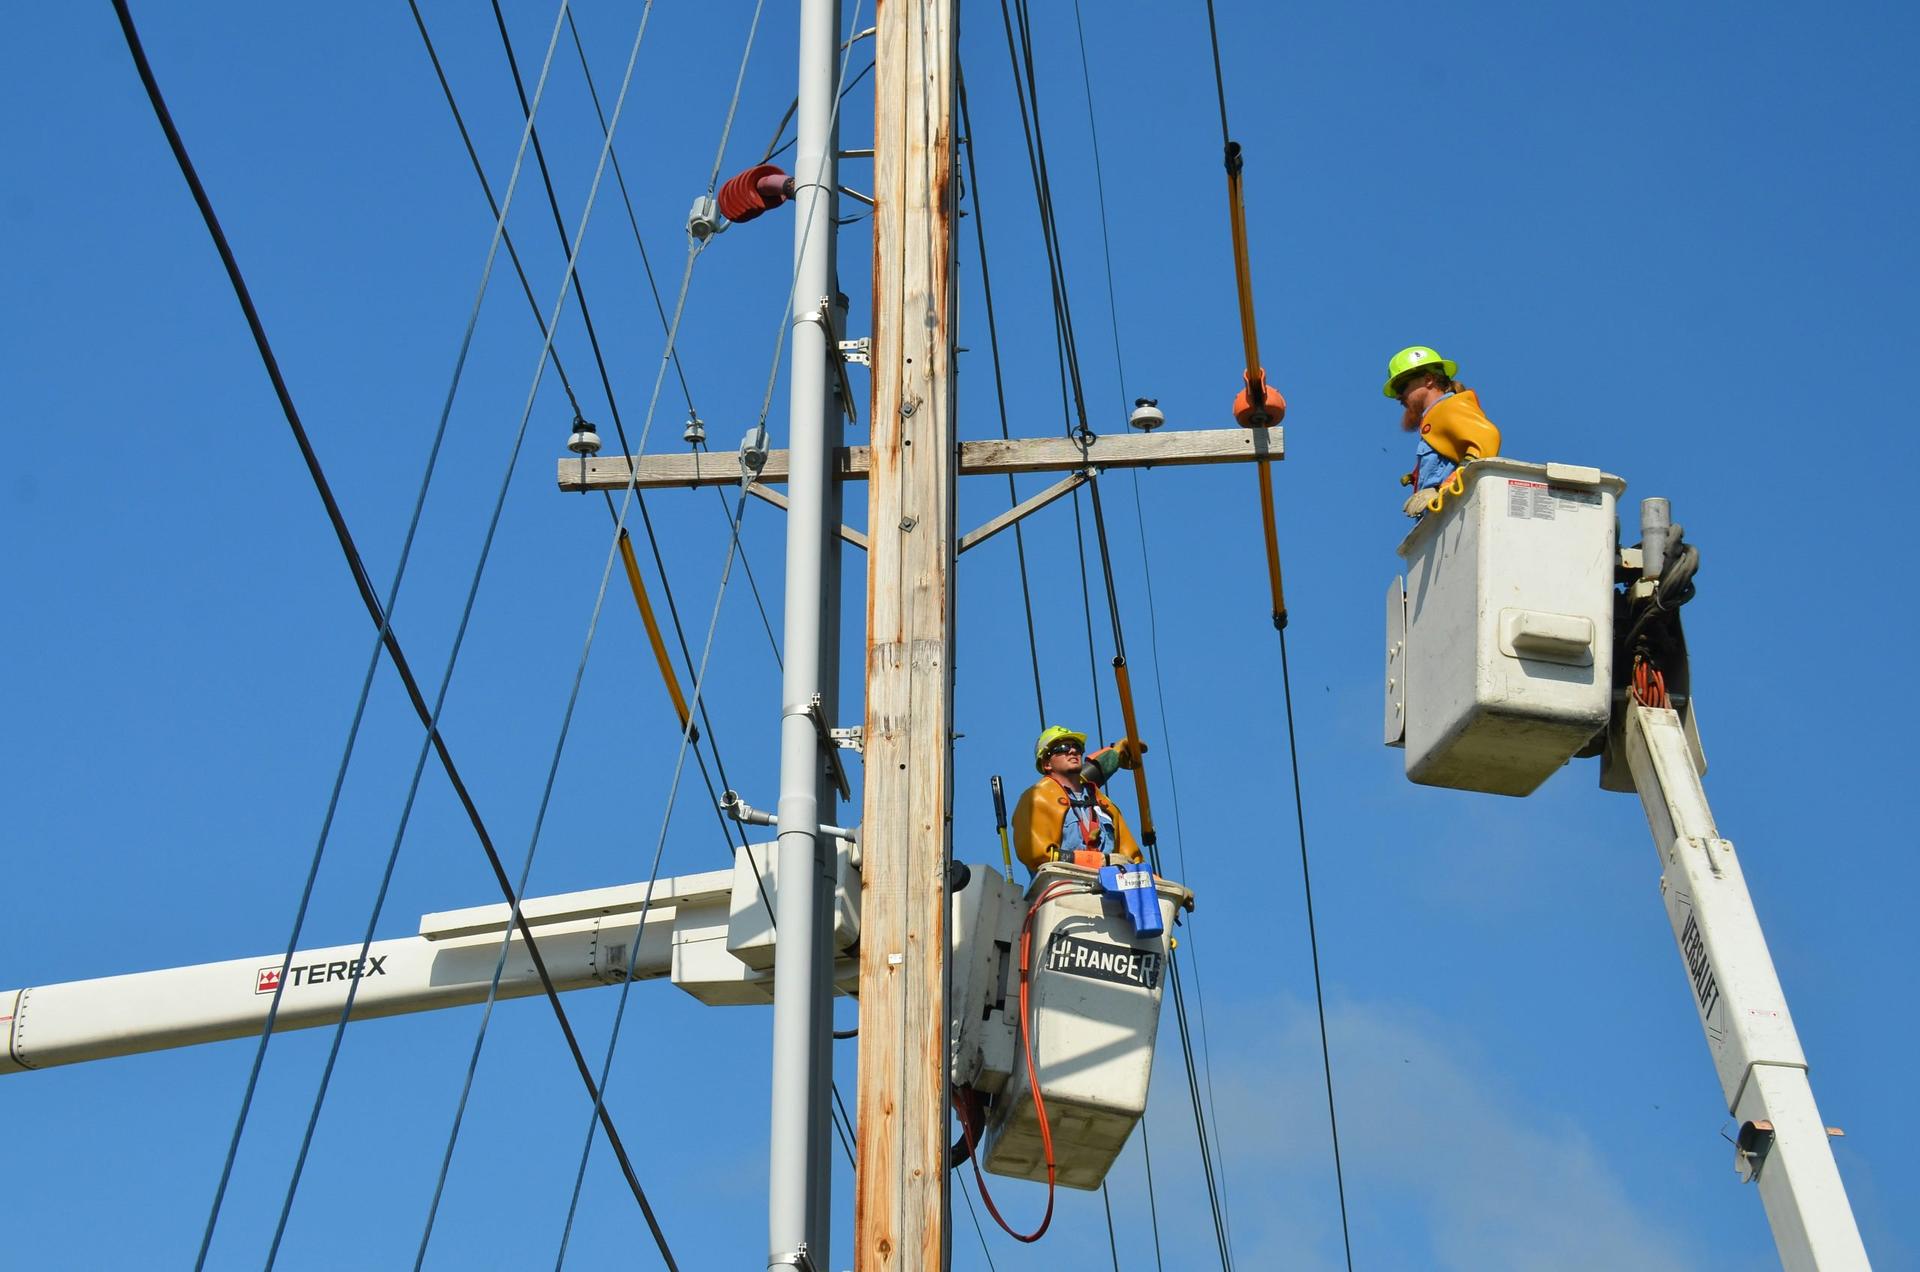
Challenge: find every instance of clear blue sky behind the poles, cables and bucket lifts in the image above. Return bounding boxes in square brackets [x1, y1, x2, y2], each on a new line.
[0, 2, 1920, 1268]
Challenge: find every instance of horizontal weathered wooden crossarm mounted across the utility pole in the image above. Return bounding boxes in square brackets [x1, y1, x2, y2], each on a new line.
[559, 428, 1286, 494]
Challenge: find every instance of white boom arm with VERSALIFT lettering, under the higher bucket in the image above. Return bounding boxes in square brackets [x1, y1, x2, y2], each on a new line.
[1626, 701, 1870, 1272]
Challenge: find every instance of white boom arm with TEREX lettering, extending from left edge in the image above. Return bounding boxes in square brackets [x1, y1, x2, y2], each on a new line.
[0, 842, 858, 1074]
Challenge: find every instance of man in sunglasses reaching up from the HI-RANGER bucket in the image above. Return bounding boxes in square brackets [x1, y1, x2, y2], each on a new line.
[1014, 724, 1146, 872]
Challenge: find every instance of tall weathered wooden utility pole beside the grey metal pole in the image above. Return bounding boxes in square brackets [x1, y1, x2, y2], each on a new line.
[854, 0, 958, 1272]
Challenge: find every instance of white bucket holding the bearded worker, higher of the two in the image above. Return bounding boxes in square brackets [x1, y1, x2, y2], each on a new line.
[1386, 457, 1626, 795]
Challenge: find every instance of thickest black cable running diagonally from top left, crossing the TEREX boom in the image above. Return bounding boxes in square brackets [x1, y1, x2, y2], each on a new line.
[113, 0, 666, 1262]
